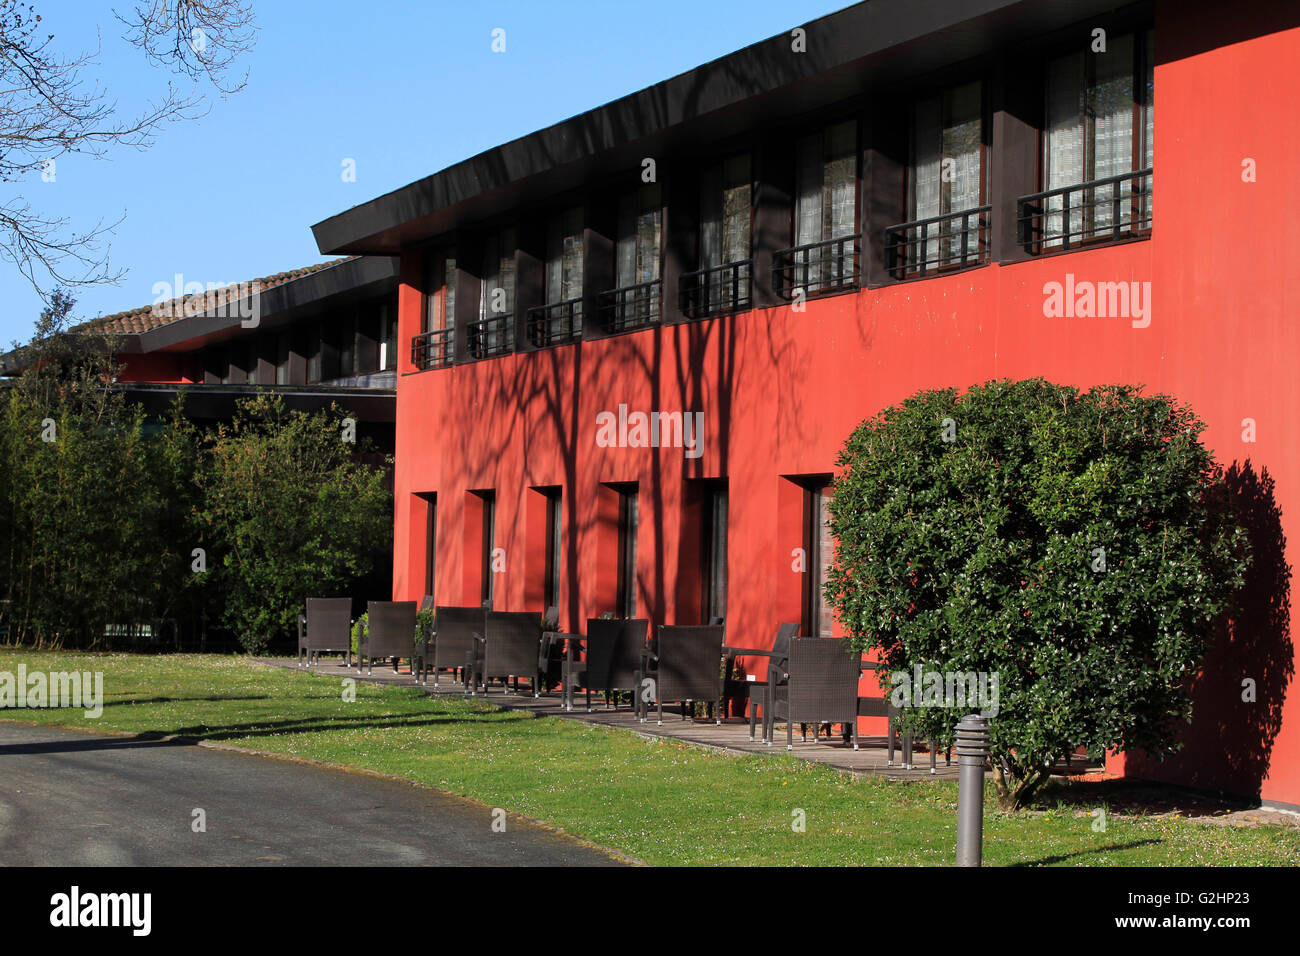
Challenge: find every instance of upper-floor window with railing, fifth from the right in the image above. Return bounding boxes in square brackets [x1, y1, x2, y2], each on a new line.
[602, 183, 663, 332]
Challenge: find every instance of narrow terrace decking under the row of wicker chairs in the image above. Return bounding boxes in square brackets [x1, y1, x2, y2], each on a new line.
[261, 658, 1101, 780]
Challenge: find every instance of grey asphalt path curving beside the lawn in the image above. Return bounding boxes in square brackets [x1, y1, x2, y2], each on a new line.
[0, 721, 618, 866]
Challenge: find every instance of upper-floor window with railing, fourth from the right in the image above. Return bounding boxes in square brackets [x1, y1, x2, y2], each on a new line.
[683, 153, 753, 316]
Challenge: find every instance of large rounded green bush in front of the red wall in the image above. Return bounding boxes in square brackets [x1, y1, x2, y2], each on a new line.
[826, 378, 1249, 809]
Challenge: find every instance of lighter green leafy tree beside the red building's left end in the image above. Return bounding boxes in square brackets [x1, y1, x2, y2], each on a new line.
[199, 395, 393, 653]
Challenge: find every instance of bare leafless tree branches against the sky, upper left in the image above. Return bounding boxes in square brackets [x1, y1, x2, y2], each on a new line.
[0, 0, 254, 295]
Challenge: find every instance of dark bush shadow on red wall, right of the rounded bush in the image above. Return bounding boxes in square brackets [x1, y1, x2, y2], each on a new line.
[1126, 460, 1295, 797]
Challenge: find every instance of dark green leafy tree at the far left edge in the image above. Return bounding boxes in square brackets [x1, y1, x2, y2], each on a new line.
[0, 290, 194, 646]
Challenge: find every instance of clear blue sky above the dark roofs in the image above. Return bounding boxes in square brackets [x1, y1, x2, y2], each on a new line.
[0, 0, 849, 347]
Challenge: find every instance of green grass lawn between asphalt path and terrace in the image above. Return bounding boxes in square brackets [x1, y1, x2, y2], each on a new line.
[0, 648, 1300, 866]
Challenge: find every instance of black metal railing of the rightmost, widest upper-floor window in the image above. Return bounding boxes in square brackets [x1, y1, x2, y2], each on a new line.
[1017, 169, 1152, 254]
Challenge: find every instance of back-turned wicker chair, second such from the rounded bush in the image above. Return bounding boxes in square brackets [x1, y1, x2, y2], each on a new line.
[636, 624, 727, 726]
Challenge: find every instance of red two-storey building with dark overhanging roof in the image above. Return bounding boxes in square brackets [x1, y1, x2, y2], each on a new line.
[315, 0, 1300, 806]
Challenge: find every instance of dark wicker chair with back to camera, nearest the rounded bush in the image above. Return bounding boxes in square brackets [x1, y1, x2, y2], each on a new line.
[763, 637, 862, 750]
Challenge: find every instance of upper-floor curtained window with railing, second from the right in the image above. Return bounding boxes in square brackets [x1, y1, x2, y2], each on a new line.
[907, 81, 984, 267]
